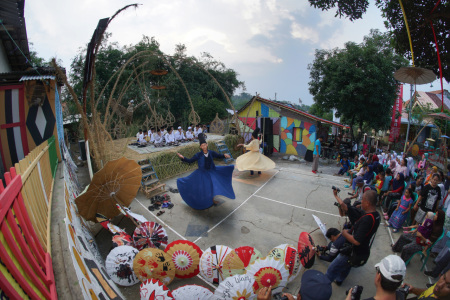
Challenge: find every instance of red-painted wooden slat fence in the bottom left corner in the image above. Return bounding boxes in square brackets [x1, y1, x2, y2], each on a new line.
[0, 165, 57, 299]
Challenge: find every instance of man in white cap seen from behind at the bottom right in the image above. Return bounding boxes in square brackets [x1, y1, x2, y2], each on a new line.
[346, 255, 406, 300]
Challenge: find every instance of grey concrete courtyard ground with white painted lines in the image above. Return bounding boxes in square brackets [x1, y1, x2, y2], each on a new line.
[93, 159, 438, 299]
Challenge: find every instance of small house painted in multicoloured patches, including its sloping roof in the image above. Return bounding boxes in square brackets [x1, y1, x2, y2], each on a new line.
[238, 96, 345, 160]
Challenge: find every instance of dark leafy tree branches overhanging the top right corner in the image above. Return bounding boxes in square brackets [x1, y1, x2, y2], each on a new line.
[309, 0, 450, 82]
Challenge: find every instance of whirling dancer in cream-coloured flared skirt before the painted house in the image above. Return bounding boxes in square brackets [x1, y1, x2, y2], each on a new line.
[236, 127, 275, 175]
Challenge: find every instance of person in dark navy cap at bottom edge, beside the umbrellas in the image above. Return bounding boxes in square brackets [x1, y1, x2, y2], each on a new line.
[257, 270, 333, 300]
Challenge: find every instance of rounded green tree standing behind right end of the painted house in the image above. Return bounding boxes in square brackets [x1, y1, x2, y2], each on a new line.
[308, 30, 405, 144]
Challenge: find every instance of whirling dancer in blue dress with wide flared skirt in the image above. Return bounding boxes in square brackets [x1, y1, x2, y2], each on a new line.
[177, 133, 235, 209]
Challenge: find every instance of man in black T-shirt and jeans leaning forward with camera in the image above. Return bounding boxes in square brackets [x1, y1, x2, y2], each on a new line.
[326, 189, 381, 285]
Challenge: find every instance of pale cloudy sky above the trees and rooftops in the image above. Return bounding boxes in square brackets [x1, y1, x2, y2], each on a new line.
[25, 0, 449, 105]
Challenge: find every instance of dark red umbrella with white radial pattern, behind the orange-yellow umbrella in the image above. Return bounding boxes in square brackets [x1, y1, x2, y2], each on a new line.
[133, 222, 167, 250]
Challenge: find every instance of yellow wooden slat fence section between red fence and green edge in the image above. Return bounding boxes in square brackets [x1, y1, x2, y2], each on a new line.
[15, 136, 58, 253]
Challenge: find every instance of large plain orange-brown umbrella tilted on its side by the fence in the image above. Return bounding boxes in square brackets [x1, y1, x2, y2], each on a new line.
[75, 157, 142, 226]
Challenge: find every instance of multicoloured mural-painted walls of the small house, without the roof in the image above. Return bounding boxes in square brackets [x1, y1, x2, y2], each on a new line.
[239, 101, 316, 156]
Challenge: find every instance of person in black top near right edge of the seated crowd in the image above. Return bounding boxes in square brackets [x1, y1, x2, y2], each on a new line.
[414, 174, 441, 224]
